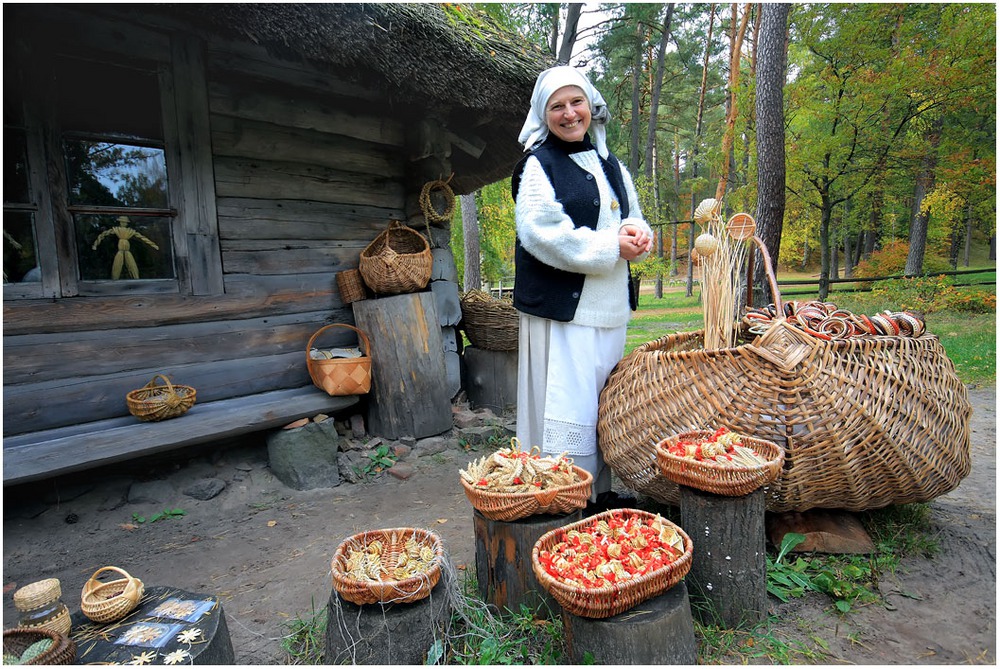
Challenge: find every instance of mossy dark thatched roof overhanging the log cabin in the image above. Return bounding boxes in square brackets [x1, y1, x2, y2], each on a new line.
[154, 3, 553, 193]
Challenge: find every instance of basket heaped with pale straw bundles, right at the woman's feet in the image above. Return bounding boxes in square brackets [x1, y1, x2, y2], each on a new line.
[459, 437, 594, 522]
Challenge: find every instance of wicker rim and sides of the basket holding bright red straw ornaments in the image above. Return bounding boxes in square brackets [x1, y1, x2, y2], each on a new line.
[531, 509, 694, 618]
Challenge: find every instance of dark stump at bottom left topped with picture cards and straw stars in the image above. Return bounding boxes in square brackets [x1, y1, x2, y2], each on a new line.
[70, 586, 236, 665]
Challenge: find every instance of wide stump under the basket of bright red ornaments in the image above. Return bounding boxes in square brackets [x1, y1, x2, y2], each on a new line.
[562, 581, 698, 665]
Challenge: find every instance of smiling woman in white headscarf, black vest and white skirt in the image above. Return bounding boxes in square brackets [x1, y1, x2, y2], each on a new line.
[511, 66, 653, 512]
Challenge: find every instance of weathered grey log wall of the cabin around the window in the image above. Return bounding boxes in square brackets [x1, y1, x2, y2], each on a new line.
[3, 6, 456, 444]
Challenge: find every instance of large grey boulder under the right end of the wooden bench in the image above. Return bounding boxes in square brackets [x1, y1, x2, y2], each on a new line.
[267, 421, 340, 490]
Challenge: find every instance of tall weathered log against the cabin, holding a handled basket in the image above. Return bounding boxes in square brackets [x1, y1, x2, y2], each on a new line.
[351, 291, 452, 439]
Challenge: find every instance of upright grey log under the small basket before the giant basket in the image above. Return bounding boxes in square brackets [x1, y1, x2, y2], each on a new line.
[680, 486, 767, 629]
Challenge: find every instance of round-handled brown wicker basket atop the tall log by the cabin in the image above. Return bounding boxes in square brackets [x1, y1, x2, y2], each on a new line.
[358, 221, 434, 295]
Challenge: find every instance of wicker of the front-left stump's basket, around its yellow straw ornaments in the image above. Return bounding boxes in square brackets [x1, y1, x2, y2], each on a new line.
[331, 527, 444, 605]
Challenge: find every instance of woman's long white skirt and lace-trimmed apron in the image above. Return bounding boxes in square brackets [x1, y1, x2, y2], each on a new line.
[517, 313, 626, 500]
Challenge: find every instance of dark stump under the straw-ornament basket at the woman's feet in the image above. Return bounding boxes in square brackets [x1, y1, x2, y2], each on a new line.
[473, 509, 583, 612]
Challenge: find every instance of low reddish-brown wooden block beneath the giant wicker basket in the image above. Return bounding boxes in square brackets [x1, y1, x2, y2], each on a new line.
[767, 510, 875, 554]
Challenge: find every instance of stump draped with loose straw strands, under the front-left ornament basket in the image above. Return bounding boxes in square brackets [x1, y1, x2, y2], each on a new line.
[323, 571, 453, 665]
